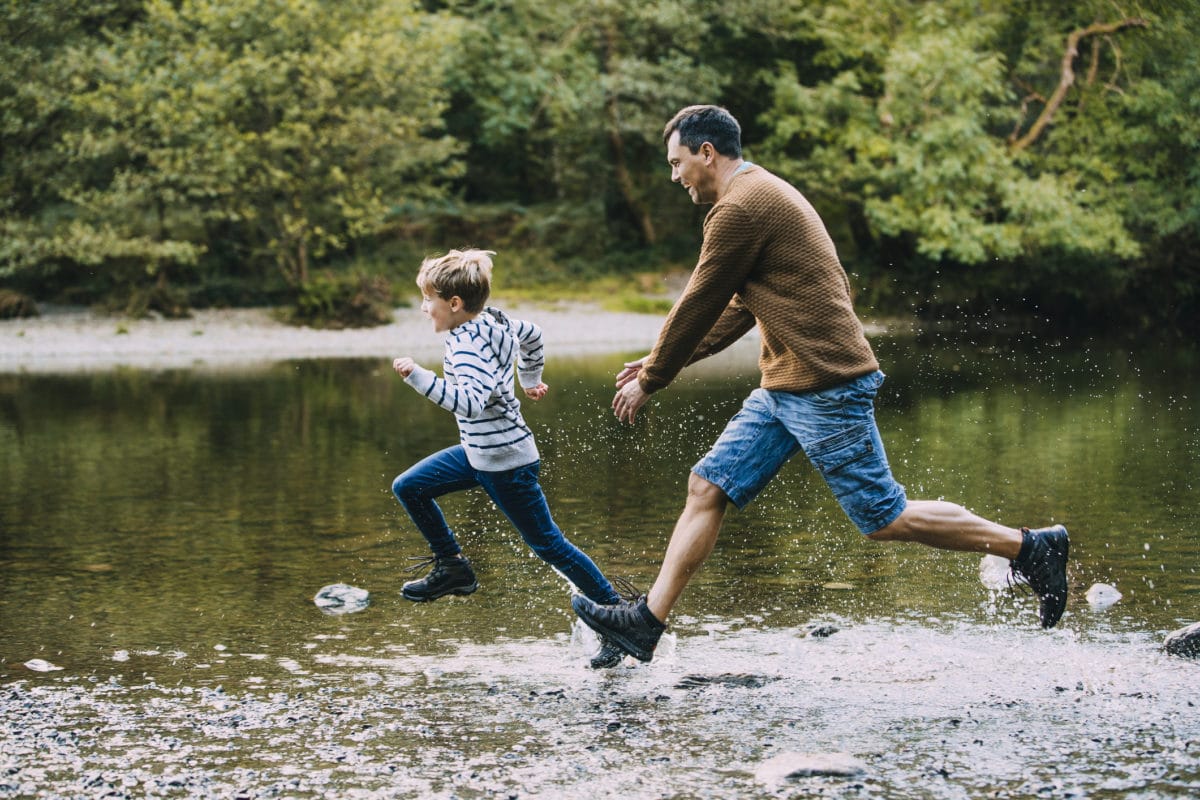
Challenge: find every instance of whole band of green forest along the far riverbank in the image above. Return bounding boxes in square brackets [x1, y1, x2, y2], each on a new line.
[0, 0, 1200, 335]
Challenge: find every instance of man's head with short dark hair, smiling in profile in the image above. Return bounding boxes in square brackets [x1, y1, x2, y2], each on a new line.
[662, 106, 742, 205]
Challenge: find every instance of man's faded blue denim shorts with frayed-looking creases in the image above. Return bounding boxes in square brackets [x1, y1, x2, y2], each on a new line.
[691, 369, 907, 534]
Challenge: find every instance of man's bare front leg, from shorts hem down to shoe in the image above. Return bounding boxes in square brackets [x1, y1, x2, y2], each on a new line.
[646, 473, 728, 622]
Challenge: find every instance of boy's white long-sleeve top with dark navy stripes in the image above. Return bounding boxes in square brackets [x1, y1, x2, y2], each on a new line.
[404, 307, 545, 473]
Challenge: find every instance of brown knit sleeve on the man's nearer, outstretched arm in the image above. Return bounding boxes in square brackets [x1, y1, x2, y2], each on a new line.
[638, 203, 758, 392]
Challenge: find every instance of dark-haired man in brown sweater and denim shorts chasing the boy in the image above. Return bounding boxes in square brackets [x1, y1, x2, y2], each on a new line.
[571, 106, 1069, 661]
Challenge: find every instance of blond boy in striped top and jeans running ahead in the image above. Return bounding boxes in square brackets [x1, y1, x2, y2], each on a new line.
[391, 249, 623, 668]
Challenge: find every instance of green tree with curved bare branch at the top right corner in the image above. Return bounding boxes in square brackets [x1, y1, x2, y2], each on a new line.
[1008, 0, 1200, 330]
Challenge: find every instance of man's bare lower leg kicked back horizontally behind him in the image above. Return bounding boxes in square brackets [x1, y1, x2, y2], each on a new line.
[870, 500, 1021, 561]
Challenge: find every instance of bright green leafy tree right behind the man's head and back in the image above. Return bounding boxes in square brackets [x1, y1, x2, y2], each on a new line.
[748, 0, 1161, 316]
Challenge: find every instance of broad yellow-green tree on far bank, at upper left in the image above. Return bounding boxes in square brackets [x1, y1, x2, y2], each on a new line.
[10, 0, 460, 309]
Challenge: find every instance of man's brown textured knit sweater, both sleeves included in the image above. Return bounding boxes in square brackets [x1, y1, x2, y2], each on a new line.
[638, 166, 878, 392]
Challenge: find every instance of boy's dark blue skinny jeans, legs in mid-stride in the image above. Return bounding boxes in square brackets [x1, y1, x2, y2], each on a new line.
[391, 445, 620, 606]
